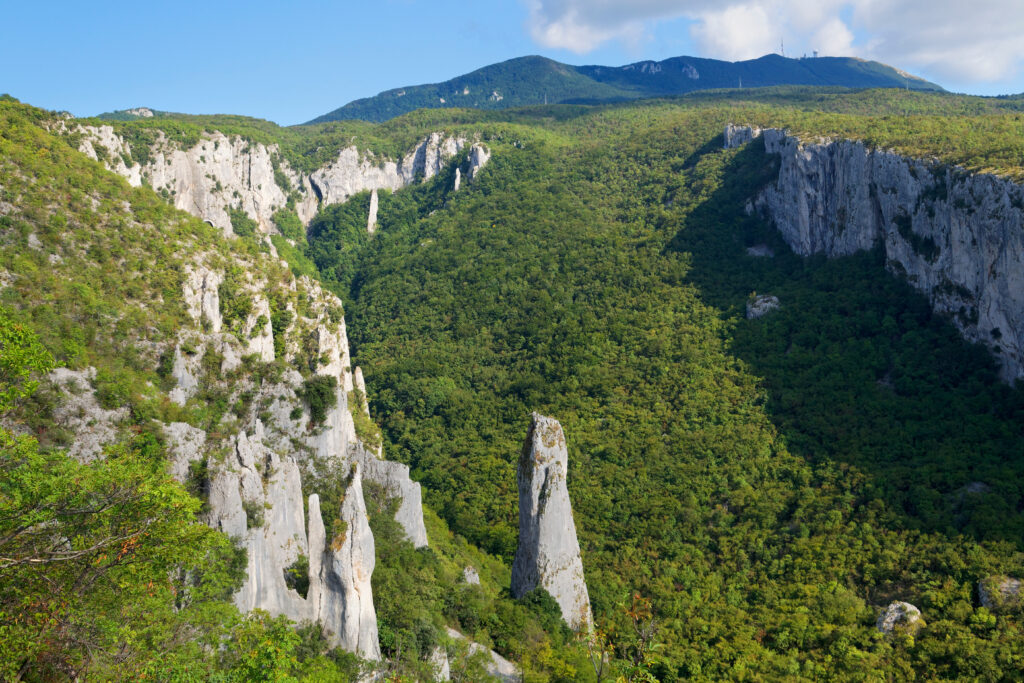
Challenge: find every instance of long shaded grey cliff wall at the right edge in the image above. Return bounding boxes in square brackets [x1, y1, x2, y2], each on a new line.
[725, 127, 1024, 381]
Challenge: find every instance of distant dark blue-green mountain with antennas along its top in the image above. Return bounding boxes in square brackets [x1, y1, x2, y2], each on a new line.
[309, 54, 943, 123]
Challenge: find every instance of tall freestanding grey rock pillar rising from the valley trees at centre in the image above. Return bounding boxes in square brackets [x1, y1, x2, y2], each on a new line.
[512, 413, 591, 631]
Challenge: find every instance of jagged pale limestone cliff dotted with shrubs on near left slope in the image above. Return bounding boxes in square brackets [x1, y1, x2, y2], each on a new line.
[50, 242, 436, 659]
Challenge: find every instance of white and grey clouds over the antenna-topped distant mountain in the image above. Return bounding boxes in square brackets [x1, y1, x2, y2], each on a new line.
[525, 0, 1024, 82]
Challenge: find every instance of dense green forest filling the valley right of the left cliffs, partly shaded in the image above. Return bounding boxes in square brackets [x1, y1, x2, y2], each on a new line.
[299, 96, 1024, 681]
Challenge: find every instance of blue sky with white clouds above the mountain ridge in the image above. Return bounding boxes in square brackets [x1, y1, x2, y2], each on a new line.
[0, 0, 1024, 124]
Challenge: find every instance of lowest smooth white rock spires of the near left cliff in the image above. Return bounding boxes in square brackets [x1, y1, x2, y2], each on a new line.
[208, 428, 380, 659]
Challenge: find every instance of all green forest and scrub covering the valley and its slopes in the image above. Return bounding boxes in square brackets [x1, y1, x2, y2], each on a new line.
[0, 88, 1024, 681]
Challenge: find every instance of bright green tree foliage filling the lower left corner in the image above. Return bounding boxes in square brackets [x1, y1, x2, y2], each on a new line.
[0, 430, 244, 679]
